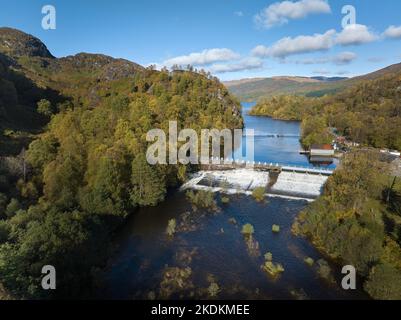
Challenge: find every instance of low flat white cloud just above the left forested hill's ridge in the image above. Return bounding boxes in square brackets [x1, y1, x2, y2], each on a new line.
[163, 48, 240, 67]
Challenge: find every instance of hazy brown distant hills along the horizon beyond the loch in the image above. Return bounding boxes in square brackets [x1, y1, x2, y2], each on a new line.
[224, 63, 401, 101]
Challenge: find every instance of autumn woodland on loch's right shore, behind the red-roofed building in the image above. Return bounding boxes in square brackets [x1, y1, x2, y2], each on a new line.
[251, 73, 401, 150]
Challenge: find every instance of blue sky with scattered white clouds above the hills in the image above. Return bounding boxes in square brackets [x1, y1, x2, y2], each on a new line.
[0, 0, 401, 80]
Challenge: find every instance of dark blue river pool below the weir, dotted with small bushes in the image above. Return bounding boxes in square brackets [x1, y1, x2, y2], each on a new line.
[101, 192, 366, 299]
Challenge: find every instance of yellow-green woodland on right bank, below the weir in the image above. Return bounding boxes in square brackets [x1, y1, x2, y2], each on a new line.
[293, 151, 401, 300]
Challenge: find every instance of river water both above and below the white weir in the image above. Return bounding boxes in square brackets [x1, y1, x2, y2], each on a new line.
[99, 104, 366, 299]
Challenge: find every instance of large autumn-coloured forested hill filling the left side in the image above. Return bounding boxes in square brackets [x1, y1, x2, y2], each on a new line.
[0, 28, 243, 298]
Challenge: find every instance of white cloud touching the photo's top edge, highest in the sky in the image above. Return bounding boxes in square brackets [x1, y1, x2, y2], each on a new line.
[255, 0, 331, 28]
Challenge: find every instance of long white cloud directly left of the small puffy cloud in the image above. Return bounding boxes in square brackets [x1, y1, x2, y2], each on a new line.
[252, 29, 336, 58]
